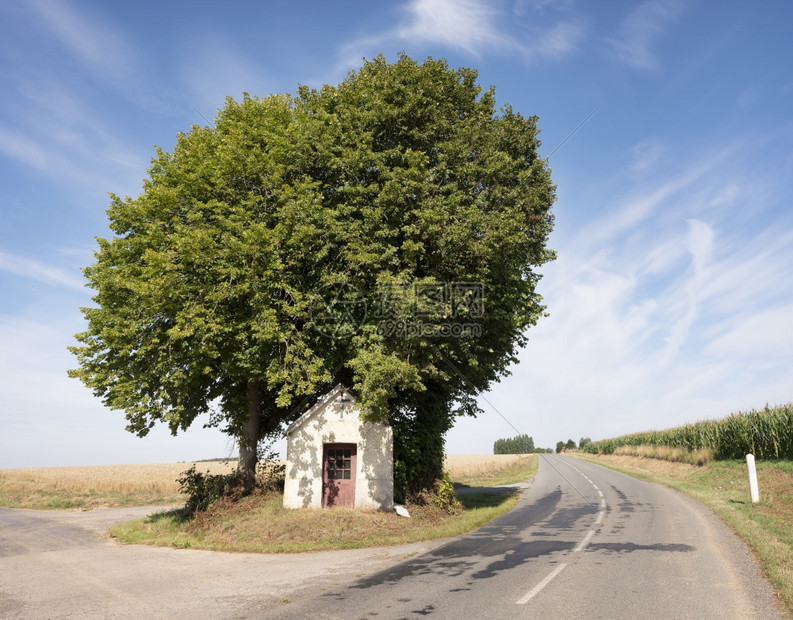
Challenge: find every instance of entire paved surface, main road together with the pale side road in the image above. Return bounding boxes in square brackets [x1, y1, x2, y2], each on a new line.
[0, 455, 784, 620]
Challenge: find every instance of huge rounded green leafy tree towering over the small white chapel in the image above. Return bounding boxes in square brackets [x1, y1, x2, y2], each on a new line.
[71, 55, 555, 493]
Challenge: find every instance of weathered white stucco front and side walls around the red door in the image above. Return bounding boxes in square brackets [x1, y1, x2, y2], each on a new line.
[284, 386, 394, 510]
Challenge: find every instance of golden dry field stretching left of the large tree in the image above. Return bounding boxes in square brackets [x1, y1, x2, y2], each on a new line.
[0, 461, 236, 509]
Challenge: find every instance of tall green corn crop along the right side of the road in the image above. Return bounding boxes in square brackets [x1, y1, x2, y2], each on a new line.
[584, 403, 793, 459]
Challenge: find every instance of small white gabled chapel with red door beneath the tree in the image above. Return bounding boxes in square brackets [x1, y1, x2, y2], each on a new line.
[284, 385, 394, 510]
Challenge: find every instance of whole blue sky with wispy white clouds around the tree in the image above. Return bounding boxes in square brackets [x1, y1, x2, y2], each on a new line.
[0, 0, 793, 467]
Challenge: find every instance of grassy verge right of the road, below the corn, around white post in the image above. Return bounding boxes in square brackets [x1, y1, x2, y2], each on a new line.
[577, 453, 793, 616]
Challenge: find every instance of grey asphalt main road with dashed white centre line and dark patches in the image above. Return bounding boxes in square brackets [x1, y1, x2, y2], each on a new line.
[266, 455, 784, 620]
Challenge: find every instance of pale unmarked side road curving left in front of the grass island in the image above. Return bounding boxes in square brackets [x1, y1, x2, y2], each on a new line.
[0, 506, 447, 619]
